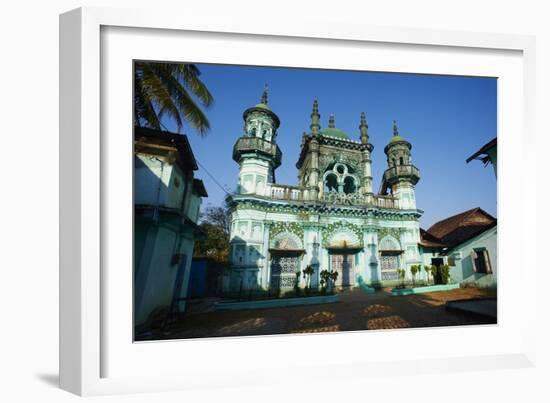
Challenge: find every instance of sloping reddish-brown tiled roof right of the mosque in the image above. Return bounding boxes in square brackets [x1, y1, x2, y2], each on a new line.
[421, 207, 497, 248]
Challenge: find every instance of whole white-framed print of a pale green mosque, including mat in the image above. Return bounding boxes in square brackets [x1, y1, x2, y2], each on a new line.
[60, 9, 536, 395]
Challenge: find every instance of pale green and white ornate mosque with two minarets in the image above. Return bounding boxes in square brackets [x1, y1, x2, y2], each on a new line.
[224, 90, 422, 291]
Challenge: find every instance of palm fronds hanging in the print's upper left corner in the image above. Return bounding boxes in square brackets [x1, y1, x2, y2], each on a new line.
[134, 61, 214, 136]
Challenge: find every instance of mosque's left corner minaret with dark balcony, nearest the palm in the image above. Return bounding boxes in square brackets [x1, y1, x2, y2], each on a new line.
[233, 87, 282, 195]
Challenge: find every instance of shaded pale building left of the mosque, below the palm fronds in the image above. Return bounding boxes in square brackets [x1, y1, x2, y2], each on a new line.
[134, 127, 207, 329]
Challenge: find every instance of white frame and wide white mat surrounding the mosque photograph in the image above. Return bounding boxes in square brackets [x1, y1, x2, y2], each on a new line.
[60, 8, 537, 395]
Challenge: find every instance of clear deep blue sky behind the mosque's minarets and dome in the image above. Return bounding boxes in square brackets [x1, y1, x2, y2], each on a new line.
[158, 64, 497, 228]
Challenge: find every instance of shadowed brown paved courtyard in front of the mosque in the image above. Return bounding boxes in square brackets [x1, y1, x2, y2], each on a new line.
[139, 288, 496, 339]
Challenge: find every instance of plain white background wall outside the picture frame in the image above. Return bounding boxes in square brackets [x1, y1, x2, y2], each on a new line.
[0, 0, 550, 403]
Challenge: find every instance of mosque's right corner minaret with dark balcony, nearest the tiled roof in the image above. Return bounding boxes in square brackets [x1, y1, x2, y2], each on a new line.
[380, 120, 420, 210]
